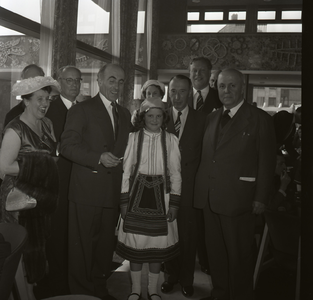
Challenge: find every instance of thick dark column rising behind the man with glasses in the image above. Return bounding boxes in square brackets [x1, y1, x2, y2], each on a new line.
[52, 0, 78, 74]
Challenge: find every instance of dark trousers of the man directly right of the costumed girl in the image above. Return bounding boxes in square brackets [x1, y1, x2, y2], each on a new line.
[165, 206, 197, 286]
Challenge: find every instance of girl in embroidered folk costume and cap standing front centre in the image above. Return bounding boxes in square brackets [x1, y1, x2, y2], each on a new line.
[116, 98, 181, 300]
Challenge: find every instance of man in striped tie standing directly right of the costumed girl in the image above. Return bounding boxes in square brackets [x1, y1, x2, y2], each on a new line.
[161, 75, 206, 297]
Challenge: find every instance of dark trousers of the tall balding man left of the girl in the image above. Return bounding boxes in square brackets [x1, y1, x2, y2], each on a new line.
[69, 202, 118, 298]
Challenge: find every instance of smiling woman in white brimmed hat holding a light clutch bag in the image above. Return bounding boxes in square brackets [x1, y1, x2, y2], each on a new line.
[0, 76, 59, 283]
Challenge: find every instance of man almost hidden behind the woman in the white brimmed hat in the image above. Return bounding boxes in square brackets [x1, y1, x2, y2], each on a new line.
[3, 64, 45, 128]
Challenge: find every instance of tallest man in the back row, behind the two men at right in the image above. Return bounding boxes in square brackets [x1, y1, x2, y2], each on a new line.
[188, 57, 222, 274]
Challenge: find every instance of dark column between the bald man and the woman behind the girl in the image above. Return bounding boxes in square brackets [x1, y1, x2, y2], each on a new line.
[119, 0, 138, 109]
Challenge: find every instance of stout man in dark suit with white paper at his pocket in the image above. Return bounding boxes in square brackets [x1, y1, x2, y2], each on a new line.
[195, 69, 276, 300]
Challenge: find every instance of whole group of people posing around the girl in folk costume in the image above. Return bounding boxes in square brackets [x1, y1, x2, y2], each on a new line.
[0, 57, 282, 300]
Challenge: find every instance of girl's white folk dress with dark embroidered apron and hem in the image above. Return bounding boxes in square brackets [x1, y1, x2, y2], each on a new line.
[116, 129, 181, 263]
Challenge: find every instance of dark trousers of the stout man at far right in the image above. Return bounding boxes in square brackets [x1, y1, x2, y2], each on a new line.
[203, 204, 255, 300]
